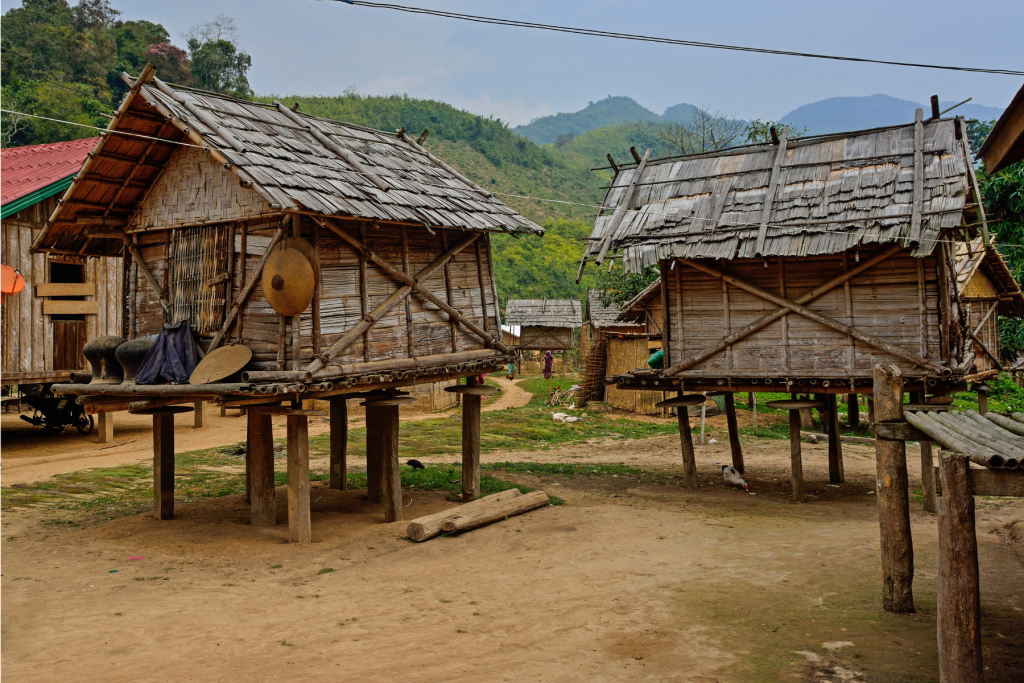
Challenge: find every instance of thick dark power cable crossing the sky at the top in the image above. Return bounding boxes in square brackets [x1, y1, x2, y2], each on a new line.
[334, 0, 1024, 76]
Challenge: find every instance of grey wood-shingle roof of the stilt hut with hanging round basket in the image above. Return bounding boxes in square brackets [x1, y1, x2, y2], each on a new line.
[34, 68, 543, 255]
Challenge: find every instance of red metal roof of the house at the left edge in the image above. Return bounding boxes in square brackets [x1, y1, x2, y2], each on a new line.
[0, 137, 99, 204]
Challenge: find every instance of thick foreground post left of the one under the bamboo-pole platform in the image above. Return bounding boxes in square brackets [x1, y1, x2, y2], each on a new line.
[874, 365, 913, 613]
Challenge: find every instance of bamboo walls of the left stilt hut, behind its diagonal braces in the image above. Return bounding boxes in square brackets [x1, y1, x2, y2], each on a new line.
[129, 217, 499, 368]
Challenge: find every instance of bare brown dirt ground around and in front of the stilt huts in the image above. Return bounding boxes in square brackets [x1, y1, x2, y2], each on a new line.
[0, 382, 1024, 683]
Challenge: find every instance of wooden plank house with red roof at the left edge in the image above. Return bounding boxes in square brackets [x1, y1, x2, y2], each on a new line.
[0, 137, 123, 385]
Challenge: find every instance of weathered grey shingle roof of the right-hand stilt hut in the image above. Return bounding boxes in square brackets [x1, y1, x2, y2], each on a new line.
[587, 119, 970, 272]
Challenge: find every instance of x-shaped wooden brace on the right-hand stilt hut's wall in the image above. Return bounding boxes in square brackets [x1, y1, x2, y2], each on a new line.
[665, 246, 949, 377]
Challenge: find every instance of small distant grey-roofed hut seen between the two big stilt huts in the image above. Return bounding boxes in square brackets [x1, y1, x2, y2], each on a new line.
[505, 299, 583, 373]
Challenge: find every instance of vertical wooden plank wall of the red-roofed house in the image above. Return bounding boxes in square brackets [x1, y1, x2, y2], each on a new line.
[0, 197, 123, 383]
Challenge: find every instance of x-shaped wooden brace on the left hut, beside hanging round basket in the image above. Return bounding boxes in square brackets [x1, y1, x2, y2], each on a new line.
[305, 217, 510, 373]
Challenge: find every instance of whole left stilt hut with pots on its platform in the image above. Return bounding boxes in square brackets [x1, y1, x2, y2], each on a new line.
[34, 67, 543, 541]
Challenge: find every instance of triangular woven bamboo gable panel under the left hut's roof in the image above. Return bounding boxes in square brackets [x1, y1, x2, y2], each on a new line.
[132, 147, 276, 229]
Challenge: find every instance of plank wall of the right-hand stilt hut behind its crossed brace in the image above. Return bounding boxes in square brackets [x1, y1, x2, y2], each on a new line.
[669, 249, 941, 374]
